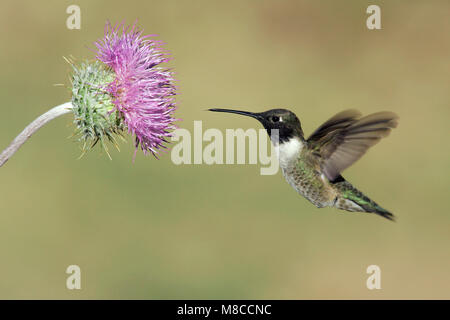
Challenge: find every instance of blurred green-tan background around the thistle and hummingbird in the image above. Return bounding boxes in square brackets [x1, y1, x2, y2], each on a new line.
[0, 0, 450, 299]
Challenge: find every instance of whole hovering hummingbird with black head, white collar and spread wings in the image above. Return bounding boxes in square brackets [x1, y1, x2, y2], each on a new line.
[209, 109, 398, 220]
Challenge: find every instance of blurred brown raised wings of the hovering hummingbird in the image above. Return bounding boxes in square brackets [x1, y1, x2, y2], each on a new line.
[307, 110, 398, 181]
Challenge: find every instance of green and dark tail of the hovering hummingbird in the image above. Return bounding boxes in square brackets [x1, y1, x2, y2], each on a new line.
[334, 179, 395, 221]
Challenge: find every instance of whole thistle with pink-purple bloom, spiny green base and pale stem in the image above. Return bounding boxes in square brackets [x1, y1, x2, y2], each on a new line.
[0, 23, 178, 166]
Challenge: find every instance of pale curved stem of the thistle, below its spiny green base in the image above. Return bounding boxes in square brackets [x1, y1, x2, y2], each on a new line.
[0, 102, 73, 167]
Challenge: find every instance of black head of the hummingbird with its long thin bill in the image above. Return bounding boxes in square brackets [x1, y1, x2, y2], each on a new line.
[209, 109, 303, 143]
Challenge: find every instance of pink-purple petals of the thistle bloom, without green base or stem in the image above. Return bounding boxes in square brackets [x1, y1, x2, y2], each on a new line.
[95, 23, 176, 155]
